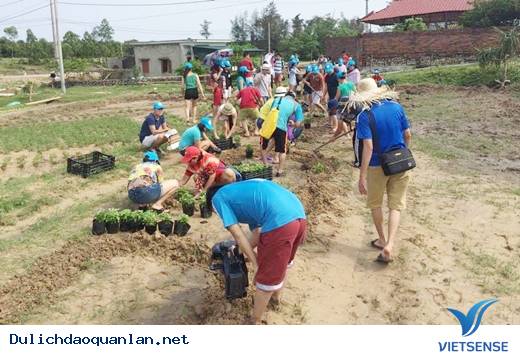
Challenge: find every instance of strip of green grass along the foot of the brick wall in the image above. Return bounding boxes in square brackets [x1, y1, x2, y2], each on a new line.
[385, 62, 520, 86]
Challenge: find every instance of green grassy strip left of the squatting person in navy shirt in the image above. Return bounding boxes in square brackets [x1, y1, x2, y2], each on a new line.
[0, 116, 140, 152]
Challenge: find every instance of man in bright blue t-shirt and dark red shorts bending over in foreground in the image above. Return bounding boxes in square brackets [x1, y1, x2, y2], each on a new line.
[206, 179, 307, 324]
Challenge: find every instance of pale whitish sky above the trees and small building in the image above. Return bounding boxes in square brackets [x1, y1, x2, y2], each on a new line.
[0, 0, 389, 41]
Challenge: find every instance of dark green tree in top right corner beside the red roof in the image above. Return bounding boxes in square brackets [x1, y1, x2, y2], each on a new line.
[459, 0, 520, 27]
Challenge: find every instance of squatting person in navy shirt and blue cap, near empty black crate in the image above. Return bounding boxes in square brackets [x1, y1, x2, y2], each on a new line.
[139, 101, 170, 149]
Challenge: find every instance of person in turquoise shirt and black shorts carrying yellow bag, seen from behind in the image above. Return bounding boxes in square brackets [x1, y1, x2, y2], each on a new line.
[260, 86, 303, 176]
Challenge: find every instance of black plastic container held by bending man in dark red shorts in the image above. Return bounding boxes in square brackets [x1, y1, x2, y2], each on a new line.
[210, 240, 249, 300]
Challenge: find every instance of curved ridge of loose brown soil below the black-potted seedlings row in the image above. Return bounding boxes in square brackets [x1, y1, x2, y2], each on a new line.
[0, 233, 210, 324]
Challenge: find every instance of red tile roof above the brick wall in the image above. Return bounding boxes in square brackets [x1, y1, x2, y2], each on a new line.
[361, 0, 473, 23]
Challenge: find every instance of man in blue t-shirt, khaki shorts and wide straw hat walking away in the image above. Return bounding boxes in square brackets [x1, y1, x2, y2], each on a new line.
[349, 78, 412, 263]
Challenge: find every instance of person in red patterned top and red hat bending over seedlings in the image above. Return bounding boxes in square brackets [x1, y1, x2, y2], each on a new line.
[180, 146, 235, 192]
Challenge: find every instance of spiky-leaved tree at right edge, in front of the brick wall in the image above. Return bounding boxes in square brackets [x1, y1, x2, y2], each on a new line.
[477, 25, 520, 87]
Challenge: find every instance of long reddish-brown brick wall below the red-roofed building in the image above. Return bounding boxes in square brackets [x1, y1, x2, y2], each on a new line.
[325, 29, 498, 66]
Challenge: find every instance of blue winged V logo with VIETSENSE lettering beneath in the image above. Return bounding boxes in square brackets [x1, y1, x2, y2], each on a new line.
[439, 299, 509, 352]
